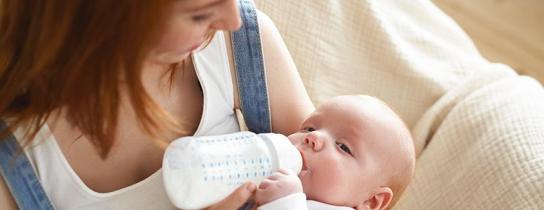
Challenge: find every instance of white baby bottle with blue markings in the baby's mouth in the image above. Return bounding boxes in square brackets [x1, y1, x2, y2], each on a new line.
[162, 132, 302, 209]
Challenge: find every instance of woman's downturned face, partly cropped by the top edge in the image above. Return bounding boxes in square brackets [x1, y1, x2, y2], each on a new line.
[150, 0, 241, 64]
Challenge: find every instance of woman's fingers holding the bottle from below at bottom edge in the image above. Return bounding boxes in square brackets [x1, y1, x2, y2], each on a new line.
[206, 182, 257, 210]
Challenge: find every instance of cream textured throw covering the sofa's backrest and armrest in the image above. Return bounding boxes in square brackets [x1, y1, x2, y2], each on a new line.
[255, 0, 544, 209]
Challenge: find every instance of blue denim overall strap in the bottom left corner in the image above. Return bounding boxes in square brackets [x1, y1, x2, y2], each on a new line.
[0, 120, 54, 210]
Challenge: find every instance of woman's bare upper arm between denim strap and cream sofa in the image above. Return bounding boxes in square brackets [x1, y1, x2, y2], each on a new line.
[257, 11, 314, 135]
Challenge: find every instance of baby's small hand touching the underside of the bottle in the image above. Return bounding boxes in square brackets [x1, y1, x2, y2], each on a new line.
[255, 169, 302, 206]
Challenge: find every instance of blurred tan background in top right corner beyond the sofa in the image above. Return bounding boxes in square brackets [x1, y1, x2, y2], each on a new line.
[433, 0, 544, 83]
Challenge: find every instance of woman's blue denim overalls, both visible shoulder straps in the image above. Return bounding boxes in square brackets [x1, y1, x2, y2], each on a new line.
[0, 0, 271, 210]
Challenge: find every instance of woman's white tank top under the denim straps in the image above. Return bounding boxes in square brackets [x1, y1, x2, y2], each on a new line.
[14, 32, 239, 210]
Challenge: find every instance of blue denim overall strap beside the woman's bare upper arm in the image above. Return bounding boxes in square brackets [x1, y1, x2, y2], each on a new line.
[231, 0, 272, 133]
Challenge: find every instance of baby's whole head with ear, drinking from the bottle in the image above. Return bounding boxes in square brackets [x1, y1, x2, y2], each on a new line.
[289, 96, 415, 209]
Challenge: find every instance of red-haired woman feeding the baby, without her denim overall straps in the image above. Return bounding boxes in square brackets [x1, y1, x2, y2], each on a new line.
[0, 0, 313, 209]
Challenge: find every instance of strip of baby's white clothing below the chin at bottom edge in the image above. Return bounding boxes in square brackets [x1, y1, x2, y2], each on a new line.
[257, 193, 353, 210]
